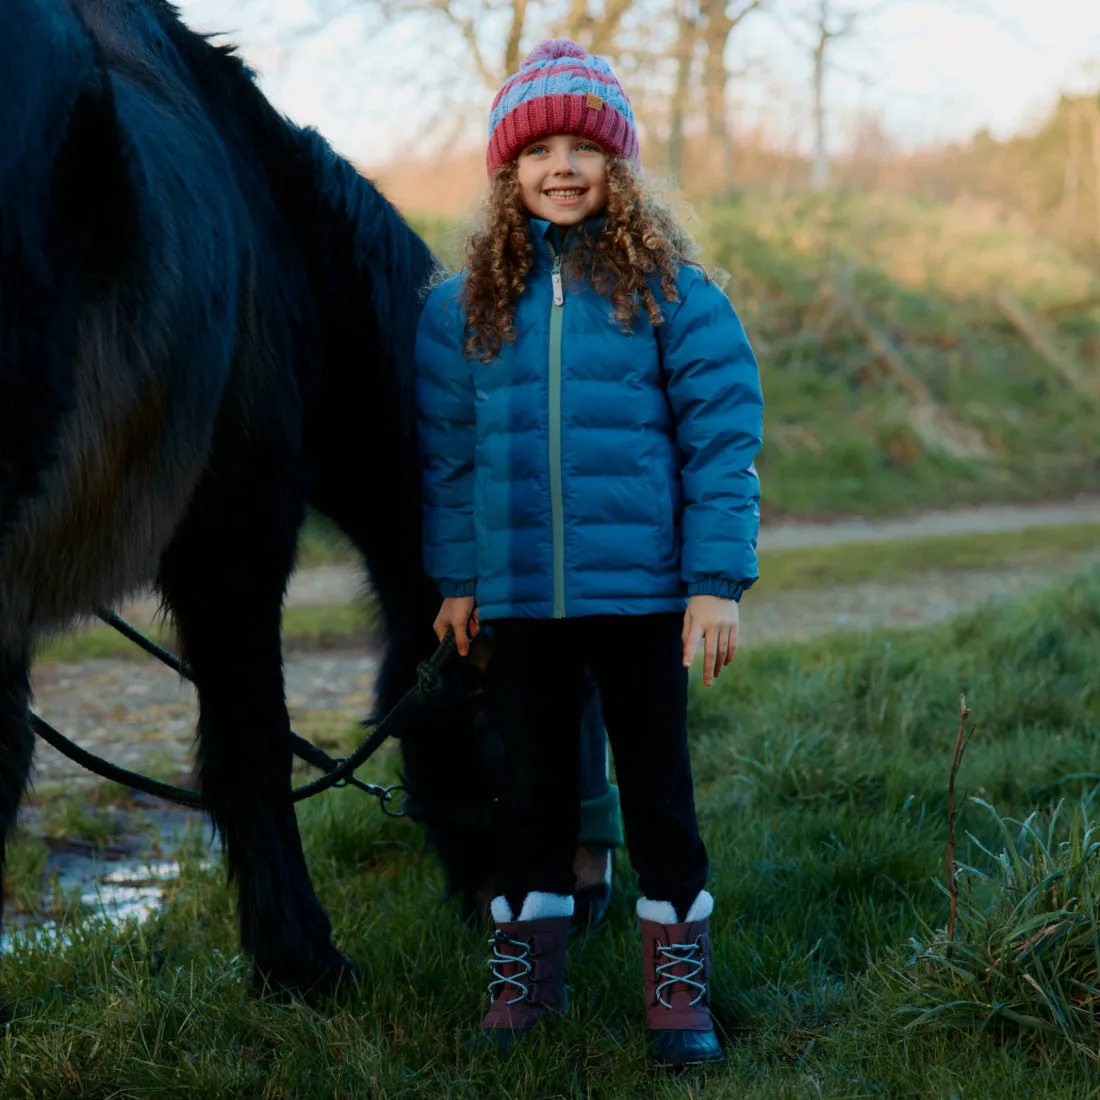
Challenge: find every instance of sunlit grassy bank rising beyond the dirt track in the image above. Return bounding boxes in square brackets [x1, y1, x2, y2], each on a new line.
[417, 191, 1100, 516]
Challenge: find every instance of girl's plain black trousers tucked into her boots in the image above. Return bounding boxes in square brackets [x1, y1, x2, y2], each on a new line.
[491, 613, 707, 919]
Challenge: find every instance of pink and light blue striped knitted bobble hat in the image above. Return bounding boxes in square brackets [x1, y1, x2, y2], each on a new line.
[485, 39, 638, 179]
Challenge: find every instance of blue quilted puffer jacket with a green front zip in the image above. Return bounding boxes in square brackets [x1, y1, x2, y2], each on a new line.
[416, 218, 763, 620]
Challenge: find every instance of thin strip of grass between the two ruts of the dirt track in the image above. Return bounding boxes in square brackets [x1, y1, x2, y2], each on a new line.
[39, 524, 1100, 662]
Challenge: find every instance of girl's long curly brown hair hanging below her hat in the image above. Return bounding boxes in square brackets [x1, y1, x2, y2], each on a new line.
[463, 156, 711, 362]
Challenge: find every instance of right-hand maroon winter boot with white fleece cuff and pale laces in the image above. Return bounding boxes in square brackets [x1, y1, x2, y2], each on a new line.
[638, 890, 723, 1066]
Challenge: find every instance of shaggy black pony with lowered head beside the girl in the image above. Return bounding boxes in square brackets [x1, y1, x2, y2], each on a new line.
[0, 0, 491, 987]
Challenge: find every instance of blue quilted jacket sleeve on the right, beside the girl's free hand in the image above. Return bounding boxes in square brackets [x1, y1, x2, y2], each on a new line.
[657, 267, 763, 600]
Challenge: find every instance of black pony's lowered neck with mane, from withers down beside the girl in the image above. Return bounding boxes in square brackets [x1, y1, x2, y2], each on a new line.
[161, 4, 435, 602]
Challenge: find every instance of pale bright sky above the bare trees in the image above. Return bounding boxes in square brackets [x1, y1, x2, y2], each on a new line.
[177, 0, 1100, 165]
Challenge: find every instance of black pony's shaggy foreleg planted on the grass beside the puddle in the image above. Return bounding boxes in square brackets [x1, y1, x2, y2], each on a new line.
[158, 459, 351, 990]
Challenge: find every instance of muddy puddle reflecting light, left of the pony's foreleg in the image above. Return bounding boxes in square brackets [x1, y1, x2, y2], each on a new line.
[0, 798, 221, 954]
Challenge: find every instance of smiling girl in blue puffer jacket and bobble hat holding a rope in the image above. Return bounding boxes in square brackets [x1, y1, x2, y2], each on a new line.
[416, 40, 763, 1064]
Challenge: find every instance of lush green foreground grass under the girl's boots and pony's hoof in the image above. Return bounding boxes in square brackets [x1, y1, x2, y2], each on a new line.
[0, 570, 1100, 1100]
